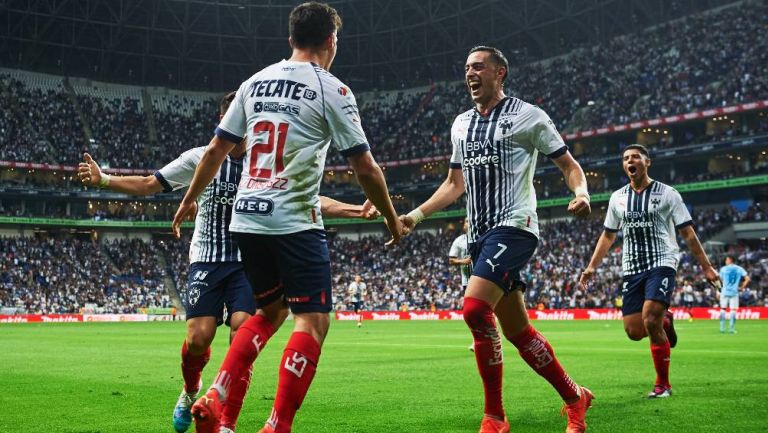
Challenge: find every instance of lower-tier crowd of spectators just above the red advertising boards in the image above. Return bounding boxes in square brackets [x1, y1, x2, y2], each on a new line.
[0, 204, 768, 313]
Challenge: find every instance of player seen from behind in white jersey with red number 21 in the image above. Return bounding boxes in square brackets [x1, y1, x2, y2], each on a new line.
[173, 3, 402, 433]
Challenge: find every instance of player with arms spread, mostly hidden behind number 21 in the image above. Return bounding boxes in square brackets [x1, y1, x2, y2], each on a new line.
[78, 92, 377, 432]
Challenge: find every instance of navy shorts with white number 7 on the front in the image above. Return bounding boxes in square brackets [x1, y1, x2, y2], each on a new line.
[469, 227, 539, 294]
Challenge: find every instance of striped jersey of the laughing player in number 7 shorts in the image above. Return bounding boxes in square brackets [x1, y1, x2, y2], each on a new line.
[451, 98, 568, 243]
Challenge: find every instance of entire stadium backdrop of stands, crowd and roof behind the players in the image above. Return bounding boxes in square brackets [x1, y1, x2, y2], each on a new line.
[0, 0, 768, 314]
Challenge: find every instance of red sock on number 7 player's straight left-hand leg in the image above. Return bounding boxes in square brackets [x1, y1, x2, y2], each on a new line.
[464, 298, 504, 419]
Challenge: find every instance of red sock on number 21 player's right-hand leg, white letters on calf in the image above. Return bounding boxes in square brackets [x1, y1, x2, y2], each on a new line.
[268, 331, 320, 433]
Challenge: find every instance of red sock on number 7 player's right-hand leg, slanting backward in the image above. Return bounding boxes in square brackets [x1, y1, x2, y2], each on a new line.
[510, 325, 579, 401]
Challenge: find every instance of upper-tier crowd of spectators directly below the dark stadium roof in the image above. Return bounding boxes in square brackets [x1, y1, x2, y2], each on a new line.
[6, 3, 768, 169]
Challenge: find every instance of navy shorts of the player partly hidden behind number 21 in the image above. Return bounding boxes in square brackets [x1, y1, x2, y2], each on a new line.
[187, 262, 256, 325]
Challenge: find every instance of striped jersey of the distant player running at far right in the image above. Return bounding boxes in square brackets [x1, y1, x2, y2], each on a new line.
[605, 181, 693, 275]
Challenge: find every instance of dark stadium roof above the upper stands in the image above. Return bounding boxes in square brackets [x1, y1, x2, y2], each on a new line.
[0, 0, 733, 91]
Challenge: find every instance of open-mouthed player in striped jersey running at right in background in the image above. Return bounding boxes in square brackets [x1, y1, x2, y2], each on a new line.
[579, 144, 719, 398]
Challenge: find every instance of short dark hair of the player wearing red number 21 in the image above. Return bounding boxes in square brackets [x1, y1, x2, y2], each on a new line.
[288, 2, 341, 48]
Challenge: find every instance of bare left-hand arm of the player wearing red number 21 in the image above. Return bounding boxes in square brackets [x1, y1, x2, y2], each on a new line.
[172, 136, 237, 238]
